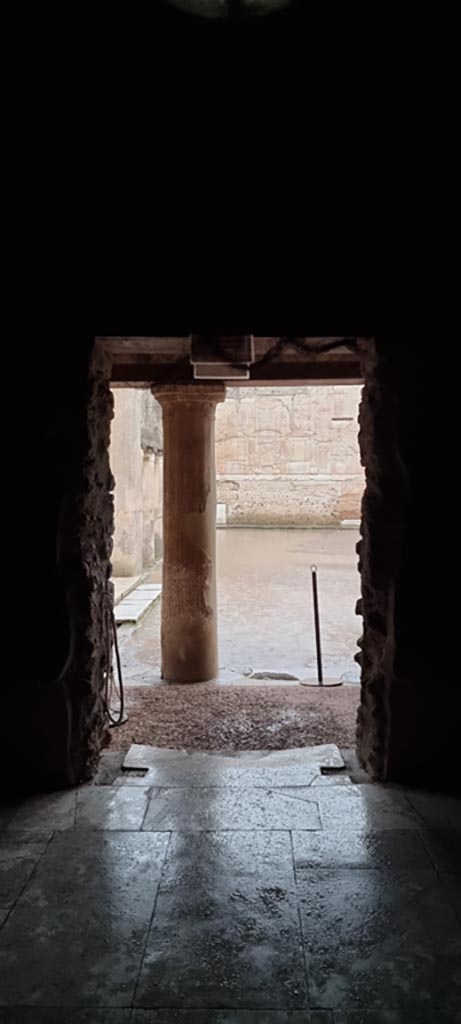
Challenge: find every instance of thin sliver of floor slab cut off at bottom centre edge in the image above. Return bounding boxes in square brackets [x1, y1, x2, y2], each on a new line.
[131, 1010, 333, 1024]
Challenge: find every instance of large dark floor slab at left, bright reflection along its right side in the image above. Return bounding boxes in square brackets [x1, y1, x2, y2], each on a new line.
[0, 831, 168, 1003]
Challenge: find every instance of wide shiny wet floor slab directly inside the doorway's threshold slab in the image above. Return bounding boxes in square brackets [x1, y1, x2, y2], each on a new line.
[142, 786, 321, 831]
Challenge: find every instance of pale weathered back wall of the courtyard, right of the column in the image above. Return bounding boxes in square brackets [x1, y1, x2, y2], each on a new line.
[216, 385, 364, 526]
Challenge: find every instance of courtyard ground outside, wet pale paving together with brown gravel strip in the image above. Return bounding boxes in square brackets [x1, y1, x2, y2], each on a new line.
[109, 528, 362, 751]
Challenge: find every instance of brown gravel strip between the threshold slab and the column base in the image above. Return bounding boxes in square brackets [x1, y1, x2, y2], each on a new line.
[111, 683, 360, 751]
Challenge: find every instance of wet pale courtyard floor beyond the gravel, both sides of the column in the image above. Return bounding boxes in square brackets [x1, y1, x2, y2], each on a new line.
[122, 529, 362, 685]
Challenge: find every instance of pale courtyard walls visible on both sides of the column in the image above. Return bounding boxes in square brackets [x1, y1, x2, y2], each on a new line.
[111, 385, 364, 544]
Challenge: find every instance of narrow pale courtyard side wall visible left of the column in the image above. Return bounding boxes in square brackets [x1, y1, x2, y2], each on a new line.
[110, 388, 162, 577]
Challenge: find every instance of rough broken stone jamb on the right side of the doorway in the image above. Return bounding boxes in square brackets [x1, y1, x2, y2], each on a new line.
[357, 341, 407, 779]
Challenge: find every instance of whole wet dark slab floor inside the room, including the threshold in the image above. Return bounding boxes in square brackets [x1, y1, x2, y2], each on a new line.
[0, 749, 461, 1024]
